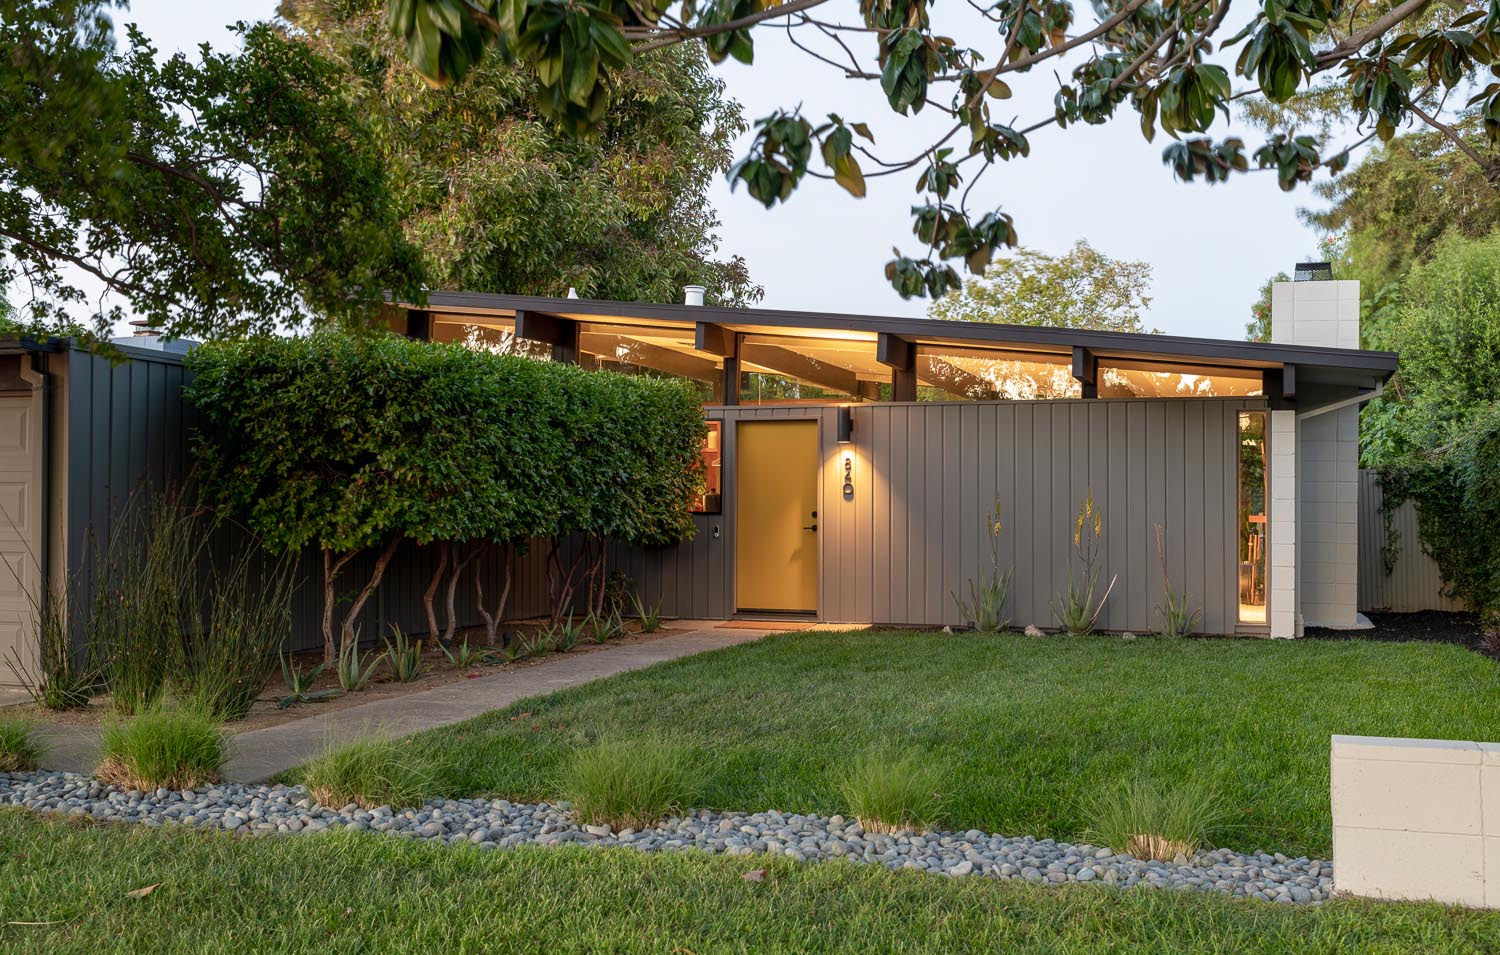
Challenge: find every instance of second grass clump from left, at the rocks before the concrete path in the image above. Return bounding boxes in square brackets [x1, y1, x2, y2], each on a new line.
[95, 699, 228, 792]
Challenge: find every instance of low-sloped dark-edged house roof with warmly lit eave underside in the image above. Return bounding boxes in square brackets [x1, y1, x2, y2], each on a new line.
[402, 292, 1397, 385]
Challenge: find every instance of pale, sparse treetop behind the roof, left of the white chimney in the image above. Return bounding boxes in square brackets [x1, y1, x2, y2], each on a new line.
[927, 238, 1155, 331]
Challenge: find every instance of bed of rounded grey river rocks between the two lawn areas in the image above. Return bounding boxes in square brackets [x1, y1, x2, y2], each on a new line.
[0, 772, 1334, 904]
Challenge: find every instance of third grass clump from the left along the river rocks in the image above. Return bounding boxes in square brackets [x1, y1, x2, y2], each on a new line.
[302, 736, 440, 810]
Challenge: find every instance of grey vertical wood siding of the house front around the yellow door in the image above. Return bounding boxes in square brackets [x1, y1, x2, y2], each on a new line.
[579, 399, 1265, 633]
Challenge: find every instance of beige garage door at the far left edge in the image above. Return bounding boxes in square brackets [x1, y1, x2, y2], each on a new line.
[0, 393, 41, 685]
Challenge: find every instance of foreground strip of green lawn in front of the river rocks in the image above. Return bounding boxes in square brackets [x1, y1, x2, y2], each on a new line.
[0, 811, 1500, 955]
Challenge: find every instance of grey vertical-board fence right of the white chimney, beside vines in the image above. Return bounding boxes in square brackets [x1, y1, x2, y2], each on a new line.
[1359, 471, 1469, 613]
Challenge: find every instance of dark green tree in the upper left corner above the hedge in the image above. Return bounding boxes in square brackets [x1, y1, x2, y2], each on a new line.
[0, 0, 422, 336]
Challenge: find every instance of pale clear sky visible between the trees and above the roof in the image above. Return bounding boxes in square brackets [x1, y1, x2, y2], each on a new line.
[108, 0, 1338, 339]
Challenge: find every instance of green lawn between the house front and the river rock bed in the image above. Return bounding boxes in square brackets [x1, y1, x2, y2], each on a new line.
[390, 633, 1500, 858]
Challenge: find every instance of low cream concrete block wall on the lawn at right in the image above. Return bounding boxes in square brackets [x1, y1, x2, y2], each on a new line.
[1332, 736, 1500, 909]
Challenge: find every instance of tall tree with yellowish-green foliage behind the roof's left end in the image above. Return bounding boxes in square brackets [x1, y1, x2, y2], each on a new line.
[282, 0, 761, 304]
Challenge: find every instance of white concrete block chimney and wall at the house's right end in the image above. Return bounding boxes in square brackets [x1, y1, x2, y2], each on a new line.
[1271, 282, 1359, 637]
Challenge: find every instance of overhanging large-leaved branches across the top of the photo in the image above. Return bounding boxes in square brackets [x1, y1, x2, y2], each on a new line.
[387, 0, 1500, 298]
